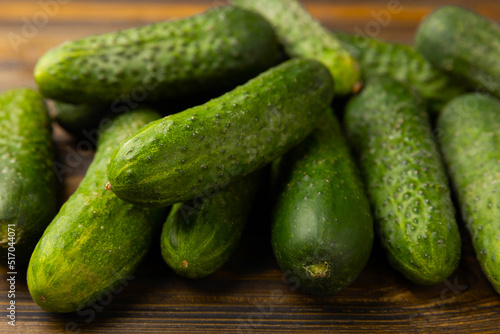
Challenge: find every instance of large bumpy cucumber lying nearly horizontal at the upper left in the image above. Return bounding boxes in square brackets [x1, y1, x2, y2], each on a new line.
[34, 6, 280, 104]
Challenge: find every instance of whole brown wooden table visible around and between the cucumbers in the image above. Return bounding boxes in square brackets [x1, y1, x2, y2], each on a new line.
[0, 0, 500, 333]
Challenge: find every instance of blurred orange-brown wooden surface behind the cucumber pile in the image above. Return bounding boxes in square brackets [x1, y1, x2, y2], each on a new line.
[0, 0, 500, 90]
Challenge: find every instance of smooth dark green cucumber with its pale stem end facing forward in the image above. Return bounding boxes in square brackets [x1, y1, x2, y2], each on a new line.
[272, 110, 373, 295]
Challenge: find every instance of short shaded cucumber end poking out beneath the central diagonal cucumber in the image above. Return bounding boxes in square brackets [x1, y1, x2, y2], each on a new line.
[161, 172, 260, 278]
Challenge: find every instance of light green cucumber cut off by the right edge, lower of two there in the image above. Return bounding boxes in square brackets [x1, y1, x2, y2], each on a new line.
[437, 94, 500, 293]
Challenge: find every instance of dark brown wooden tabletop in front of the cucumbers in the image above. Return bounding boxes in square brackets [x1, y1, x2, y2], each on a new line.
[13, 197, 499, 333]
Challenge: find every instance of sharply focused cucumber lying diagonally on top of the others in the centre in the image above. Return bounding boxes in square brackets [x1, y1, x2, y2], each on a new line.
[108, 58, 333, 207]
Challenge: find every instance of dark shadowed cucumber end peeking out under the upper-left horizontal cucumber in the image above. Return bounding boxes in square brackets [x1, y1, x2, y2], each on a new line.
[54, 101, 109, 138]
